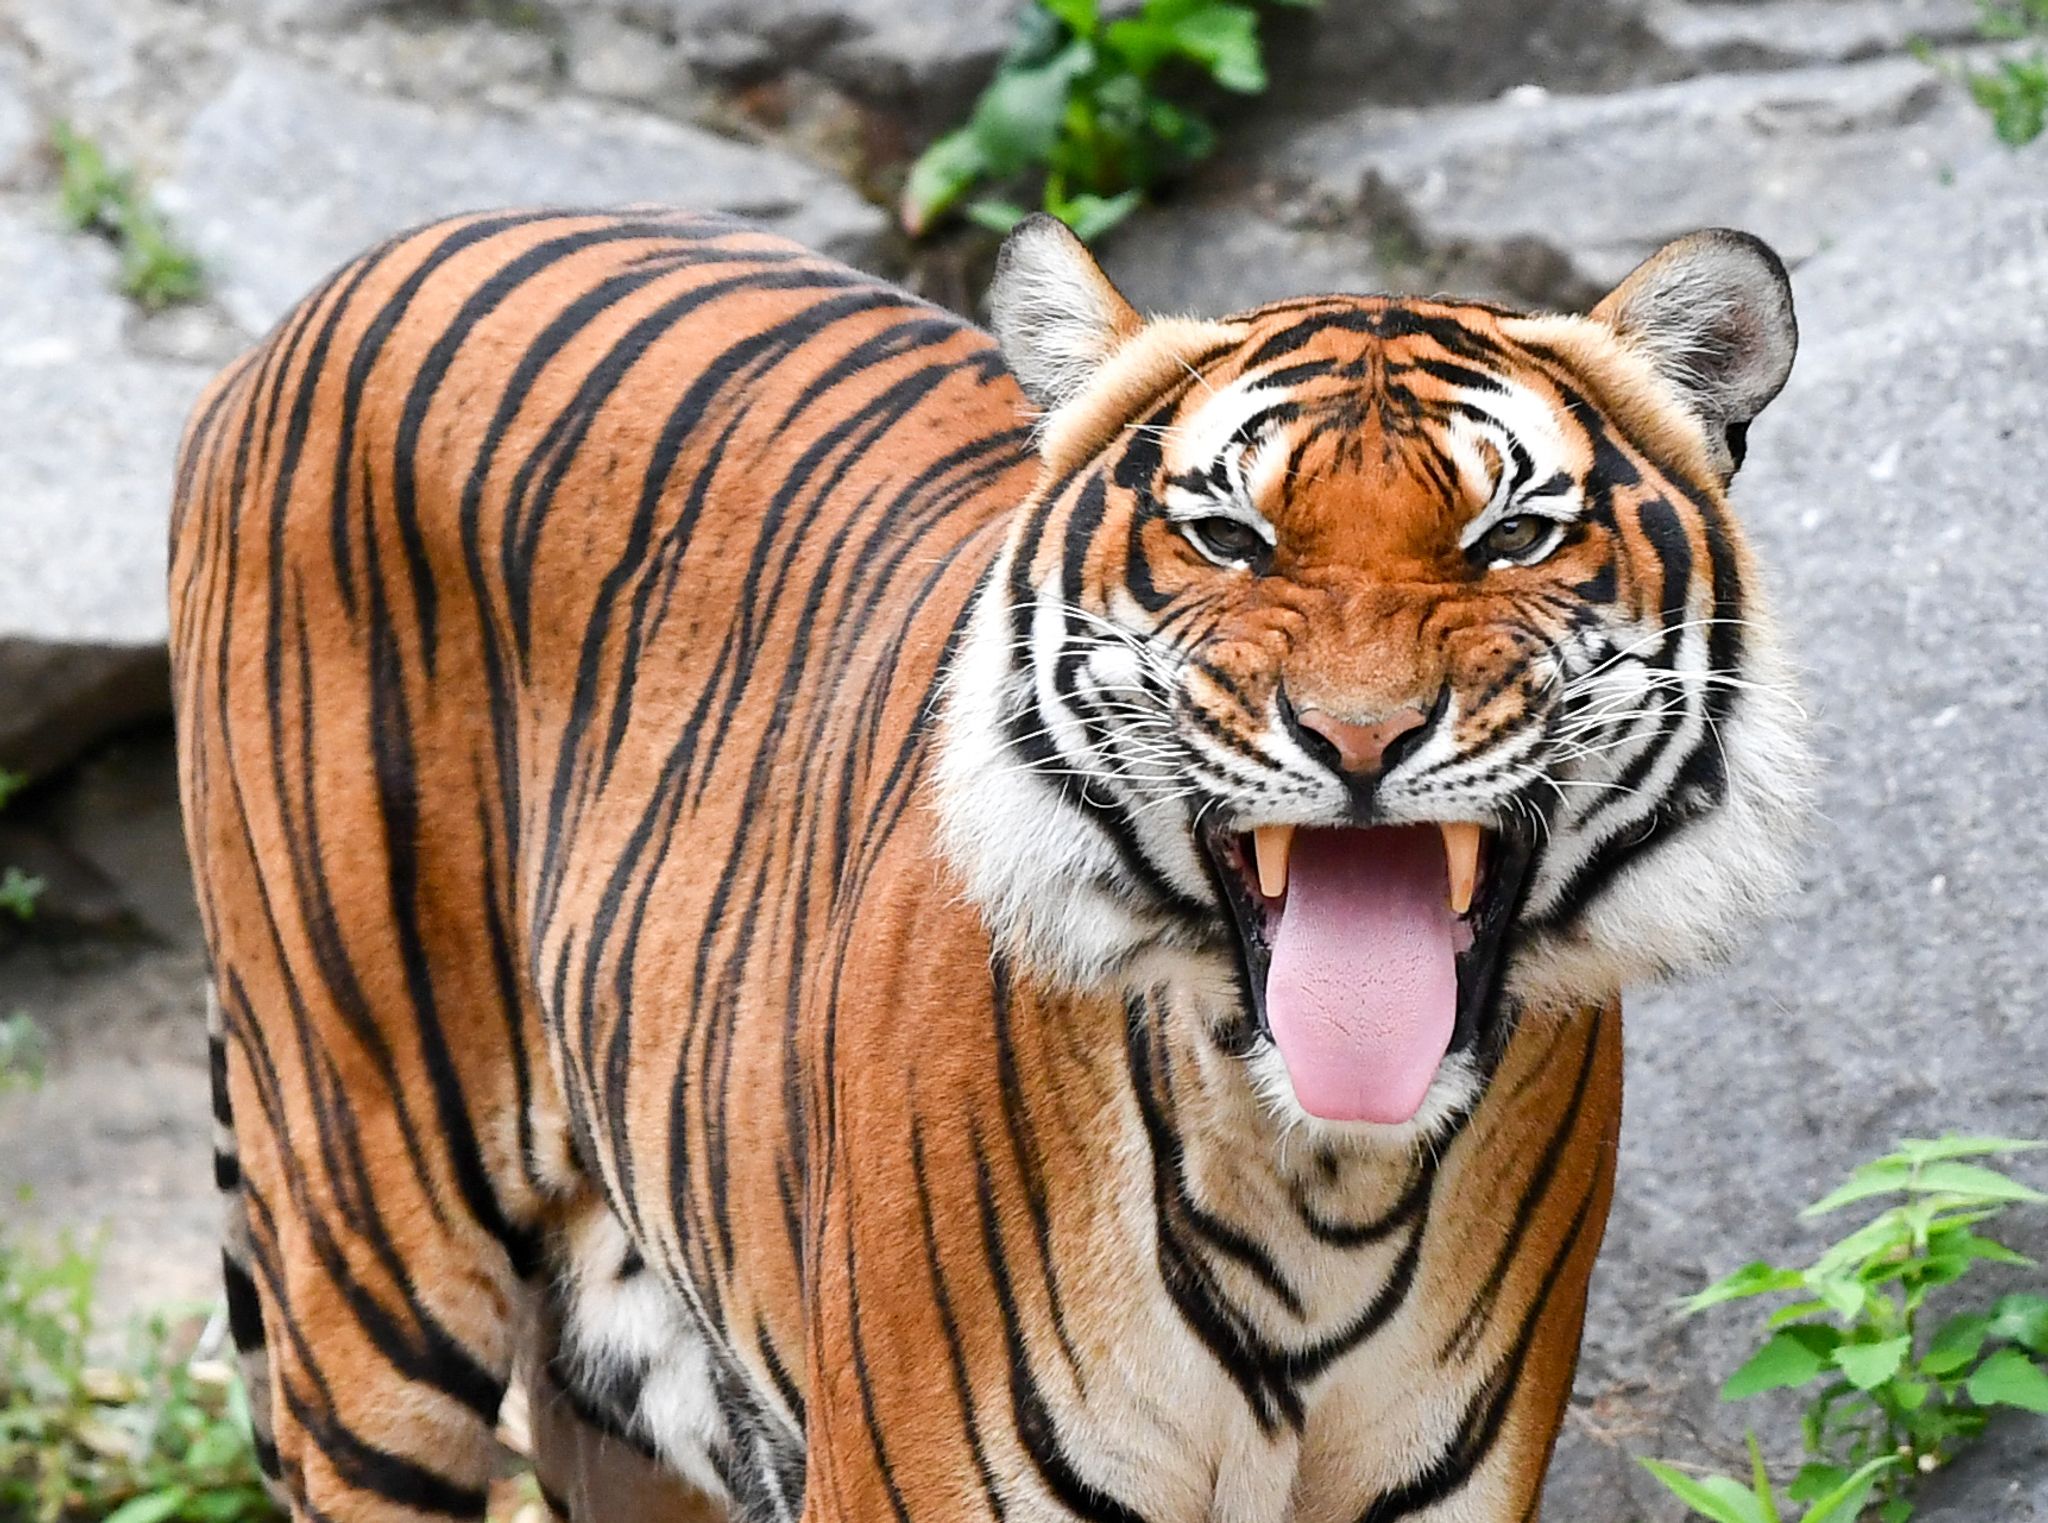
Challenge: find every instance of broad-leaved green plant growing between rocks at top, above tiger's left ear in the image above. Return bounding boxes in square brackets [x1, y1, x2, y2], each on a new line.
[903, 0, 1317, 240]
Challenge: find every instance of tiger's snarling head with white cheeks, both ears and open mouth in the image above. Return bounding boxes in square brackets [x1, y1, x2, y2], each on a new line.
[938, 217, 1812, 1126]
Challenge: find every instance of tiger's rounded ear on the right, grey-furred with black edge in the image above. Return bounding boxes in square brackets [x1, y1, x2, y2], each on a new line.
[1591, 227, 1798, 481]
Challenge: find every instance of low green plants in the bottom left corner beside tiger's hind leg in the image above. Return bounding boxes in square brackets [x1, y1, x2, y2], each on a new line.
[0, 1236, 279, 1523]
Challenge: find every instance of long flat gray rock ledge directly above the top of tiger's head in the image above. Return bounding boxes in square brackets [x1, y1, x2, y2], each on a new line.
[1288, 59, 1989, 297]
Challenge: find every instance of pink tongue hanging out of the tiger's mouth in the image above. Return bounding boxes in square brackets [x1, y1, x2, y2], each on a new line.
[1266, 825, 1458, 1126]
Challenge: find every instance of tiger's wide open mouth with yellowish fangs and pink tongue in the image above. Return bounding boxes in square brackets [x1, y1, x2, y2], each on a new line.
[1200, 823, 1530, 1126]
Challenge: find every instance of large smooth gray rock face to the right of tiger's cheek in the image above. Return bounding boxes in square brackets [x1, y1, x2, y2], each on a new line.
[1550, 141, 2048, 1523]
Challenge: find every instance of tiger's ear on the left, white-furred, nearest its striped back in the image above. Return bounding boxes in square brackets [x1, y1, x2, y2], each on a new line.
[989, 213, 1145, 414]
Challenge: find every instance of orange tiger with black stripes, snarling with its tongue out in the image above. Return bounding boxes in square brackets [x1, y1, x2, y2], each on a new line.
[170, 207, 1815, 1523]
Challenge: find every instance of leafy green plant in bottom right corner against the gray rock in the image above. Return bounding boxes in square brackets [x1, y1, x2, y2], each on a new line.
[1642, 1136, 2048, 1523]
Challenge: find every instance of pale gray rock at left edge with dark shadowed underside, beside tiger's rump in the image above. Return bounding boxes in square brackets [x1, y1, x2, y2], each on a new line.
[0, 203, 207, 774]
